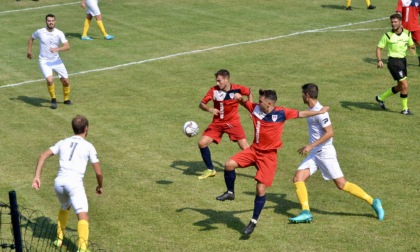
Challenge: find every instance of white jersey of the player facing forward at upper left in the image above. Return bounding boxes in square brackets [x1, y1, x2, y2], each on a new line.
[32, 27, 67, 61]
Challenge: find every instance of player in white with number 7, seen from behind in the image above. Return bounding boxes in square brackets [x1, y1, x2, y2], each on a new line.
[32, 115, 103, 252]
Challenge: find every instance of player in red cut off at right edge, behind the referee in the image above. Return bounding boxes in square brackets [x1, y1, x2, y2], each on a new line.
[396, 0, 420, 66]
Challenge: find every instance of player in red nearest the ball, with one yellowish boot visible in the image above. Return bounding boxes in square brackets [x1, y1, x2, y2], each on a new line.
[198, 69, 252, 179]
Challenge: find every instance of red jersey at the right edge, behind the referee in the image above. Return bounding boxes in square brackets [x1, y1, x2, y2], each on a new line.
[396, 0, 420, 32]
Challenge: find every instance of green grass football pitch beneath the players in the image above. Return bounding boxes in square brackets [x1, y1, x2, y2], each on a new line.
[0, 0, 420, 251]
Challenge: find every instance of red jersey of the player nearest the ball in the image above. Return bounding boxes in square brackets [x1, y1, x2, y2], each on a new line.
[201, 84, 251, 122]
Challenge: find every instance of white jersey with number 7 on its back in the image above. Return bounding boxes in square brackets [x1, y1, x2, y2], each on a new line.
[50, 136, 99, 183]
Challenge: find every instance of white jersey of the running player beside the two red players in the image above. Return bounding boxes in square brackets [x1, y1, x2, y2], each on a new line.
[306, 102, 333, 152]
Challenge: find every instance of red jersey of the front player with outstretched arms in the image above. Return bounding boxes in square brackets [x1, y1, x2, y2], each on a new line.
[245, 101, 299, 150]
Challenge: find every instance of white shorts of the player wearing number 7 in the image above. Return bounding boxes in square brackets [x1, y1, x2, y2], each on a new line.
[54, 178, 89, 214]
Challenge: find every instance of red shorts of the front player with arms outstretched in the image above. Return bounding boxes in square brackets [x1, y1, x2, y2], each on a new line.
[231, 145, 277, 186]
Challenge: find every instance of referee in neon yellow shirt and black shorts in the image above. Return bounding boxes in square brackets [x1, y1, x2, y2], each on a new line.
[376, 14, 416, 115]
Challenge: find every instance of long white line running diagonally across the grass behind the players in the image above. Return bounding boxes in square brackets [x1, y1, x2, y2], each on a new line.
[0, 17, 389, 88]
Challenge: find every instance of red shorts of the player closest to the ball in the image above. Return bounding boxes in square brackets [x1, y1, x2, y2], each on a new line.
[203, 121, 246, 144]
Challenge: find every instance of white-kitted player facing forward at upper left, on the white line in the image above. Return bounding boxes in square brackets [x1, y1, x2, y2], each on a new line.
[26, 14, 73, 109]
